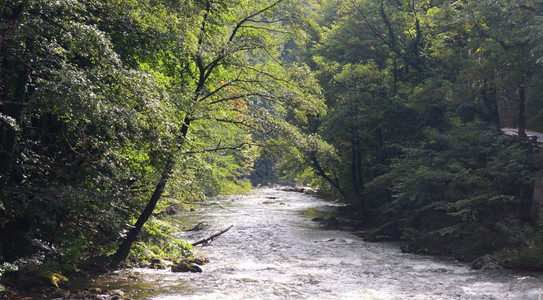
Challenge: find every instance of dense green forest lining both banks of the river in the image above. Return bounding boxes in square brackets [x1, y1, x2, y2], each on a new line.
[0, 0, 543, 289]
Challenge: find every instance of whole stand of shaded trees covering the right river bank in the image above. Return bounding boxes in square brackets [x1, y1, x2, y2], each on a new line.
[278, 0, 542, 258]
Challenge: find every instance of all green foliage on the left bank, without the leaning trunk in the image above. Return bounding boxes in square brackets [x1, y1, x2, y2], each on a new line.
[0, 0, 324, 269]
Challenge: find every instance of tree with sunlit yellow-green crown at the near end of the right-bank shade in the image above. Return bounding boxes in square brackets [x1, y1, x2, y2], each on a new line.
[296, 1, 436, 209]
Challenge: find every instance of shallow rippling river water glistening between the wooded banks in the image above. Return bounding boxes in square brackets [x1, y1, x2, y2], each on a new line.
[73, 188, 543, 300]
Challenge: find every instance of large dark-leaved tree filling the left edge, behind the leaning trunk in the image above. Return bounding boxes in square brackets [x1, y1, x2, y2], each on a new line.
[0, 0, 184, 264]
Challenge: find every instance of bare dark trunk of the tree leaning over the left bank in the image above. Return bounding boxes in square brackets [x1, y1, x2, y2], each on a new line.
[109, 118, 190, 268]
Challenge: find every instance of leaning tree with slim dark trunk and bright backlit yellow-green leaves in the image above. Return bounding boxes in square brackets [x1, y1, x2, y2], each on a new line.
[111, 0, 323, 266]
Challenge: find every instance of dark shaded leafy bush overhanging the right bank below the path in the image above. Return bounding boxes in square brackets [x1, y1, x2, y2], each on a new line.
[384, 122, 535, 258]
